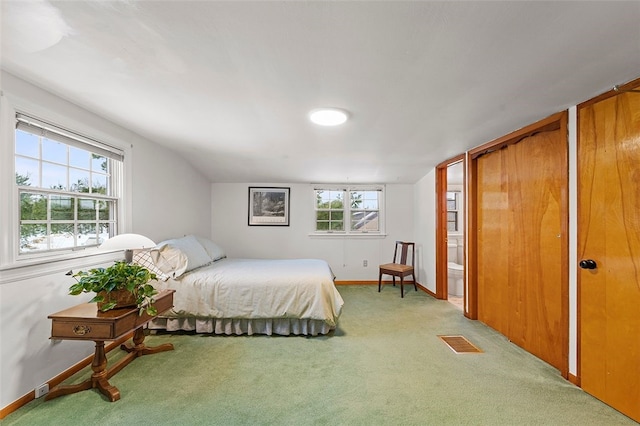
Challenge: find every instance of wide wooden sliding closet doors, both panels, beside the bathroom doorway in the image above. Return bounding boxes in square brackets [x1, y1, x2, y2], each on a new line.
[477, 119, 568, 374]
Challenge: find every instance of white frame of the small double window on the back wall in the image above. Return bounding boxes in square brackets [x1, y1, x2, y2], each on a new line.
[310, 184, 386, 237]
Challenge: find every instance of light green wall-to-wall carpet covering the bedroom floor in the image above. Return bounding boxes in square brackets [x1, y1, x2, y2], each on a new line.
[2, 286, 637, 426]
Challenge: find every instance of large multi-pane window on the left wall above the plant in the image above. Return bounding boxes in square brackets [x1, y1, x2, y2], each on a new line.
[14, 114, 123, 256]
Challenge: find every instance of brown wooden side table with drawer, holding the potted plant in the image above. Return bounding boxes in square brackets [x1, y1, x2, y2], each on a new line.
[45, 290, 175, 402]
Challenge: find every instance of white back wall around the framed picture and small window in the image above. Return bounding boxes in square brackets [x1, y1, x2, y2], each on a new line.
[211, 183, 420, 281]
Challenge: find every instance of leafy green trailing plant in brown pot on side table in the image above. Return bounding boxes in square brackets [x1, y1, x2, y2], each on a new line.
[69, 261, 158, 316]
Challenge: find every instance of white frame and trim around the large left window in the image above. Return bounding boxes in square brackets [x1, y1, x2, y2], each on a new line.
[0, 101, 131, 270]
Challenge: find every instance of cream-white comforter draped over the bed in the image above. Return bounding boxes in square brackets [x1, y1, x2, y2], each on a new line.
[156, 259, 344, 327]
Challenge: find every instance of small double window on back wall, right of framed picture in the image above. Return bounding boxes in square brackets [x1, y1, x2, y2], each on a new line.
[314, 186, 384, 234]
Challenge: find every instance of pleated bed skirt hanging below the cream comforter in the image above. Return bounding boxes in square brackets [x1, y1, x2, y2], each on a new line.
[148, 317, 335, 336]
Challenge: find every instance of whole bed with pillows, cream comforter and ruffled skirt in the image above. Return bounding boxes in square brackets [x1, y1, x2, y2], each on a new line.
[134, 236, 344, 336]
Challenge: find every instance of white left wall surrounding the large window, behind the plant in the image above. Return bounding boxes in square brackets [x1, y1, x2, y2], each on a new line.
[0, 72, 211, 407]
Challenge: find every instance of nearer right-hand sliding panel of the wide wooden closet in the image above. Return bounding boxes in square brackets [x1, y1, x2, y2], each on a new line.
[506, 131, 566, 365]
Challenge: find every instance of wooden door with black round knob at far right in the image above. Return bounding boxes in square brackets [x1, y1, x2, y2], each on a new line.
[578, 87, 640, 421]
